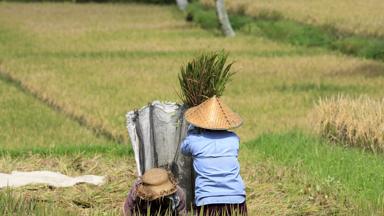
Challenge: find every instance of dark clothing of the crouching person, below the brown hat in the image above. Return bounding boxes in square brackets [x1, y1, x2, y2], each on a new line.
[123, 180, 187, 216]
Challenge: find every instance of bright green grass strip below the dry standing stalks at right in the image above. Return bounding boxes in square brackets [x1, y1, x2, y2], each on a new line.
[246, 130, 384, 214]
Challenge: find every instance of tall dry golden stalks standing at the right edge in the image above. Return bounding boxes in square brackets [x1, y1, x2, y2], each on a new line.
[312, 96, 384, 152]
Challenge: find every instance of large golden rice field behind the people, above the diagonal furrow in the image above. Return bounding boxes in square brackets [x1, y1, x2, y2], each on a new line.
[0, 3, 384, 142]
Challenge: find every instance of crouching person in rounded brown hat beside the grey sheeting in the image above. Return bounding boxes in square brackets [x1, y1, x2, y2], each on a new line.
[123, 168, 186, 216]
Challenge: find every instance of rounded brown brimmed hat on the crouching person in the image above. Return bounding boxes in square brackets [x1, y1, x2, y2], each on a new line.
[137, 168, 177, 201]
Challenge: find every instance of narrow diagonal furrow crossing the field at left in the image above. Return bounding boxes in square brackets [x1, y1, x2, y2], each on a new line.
[0, 69, 127, 144]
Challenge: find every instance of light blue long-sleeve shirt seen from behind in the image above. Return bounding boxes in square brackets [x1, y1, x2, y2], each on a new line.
[181, 129, 245, 206]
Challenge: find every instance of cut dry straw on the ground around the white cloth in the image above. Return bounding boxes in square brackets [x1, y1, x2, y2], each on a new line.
[0, 155, 136, 215]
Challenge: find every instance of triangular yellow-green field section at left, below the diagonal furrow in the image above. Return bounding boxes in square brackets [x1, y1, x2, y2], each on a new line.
[0, 76, 114, 148]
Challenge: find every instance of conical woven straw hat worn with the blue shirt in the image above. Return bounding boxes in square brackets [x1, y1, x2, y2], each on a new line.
[184, 96, 243, 130]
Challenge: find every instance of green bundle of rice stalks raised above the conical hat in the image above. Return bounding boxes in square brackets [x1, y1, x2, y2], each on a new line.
[179, 51, 234, 107]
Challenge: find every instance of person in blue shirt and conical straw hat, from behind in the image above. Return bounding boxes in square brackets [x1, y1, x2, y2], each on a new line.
[181, 96, 247, 215]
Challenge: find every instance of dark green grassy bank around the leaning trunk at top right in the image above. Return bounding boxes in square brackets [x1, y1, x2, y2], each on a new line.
[188, 3, 384, 61]
